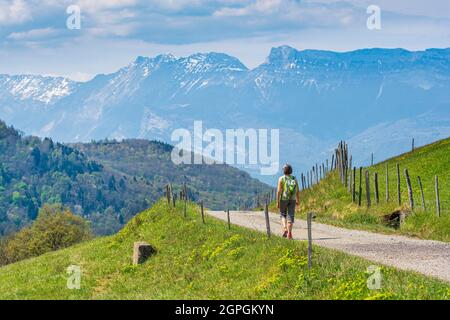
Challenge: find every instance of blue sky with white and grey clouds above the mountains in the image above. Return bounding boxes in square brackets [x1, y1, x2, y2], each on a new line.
[0, 0, 450, 80]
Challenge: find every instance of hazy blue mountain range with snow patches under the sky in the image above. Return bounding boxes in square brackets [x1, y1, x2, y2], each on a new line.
[0, 46, 450, 182]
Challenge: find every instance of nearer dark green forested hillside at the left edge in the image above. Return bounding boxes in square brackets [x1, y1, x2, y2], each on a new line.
[0, 122, 151, 235]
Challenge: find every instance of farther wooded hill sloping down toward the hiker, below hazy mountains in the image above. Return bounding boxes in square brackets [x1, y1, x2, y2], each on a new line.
[72, 139, 270, 209]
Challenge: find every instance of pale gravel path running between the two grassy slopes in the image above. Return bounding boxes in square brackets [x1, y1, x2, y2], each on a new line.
[207, 211, 450, 282]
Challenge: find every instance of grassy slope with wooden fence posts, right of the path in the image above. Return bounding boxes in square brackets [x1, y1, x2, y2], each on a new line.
[286, 139, 450, 242]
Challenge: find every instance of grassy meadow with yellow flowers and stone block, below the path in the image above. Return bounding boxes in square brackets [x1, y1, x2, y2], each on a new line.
[0, 202, 450, 299]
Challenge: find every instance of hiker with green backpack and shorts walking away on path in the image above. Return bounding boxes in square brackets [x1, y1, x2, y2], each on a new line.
[277, 164, 300, 239]
